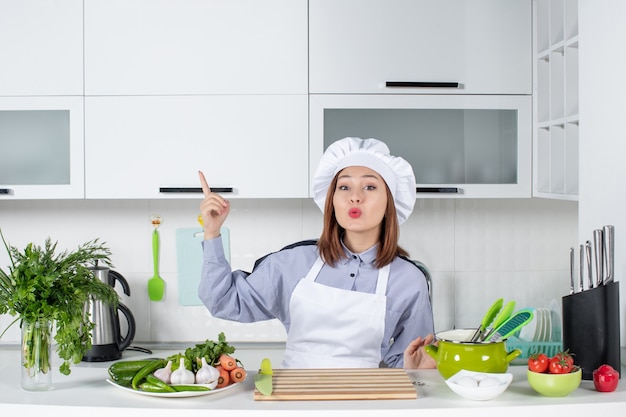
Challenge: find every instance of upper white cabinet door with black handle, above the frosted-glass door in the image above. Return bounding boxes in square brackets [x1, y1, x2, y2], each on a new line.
[309, 0, 532, 94]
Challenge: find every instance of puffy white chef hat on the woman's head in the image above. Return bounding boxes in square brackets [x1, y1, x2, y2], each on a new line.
[313, 138, 416, 224]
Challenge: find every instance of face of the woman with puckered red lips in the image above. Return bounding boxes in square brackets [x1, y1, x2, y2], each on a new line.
[333, 166, 387, 238]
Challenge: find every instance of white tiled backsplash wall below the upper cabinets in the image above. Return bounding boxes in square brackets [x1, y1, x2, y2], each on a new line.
[0, 199, 578, 346]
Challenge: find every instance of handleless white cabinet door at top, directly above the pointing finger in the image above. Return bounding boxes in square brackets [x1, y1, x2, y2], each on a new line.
[85, 0, 307, 95]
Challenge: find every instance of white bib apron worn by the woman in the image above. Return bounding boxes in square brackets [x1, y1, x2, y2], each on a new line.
[282, 257, 389, 368]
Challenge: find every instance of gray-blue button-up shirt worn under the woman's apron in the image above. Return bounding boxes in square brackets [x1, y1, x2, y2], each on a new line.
[198, 237, 434, 367]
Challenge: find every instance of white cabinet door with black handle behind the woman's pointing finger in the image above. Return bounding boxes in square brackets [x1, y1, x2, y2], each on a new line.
[85, 95, 308, 198]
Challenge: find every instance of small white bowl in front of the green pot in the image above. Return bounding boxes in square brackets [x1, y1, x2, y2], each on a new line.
[446, 370, 513, 401]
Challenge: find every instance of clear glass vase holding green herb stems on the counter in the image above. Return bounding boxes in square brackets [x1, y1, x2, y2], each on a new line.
[21, 319, 53, 391]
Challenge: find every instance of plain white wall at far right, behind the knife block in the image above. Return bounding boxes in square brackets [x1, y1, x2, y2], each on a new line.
[578, 0, 626, 347]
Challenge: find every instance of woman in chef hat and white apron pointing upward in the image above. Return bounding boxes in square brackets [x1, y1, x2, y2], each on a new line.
[199, 138, 435, 368]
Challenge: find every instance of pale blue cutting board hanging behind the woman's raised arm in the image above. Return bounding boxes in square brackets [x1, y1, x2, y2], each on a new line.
[176, 227, 230, 306]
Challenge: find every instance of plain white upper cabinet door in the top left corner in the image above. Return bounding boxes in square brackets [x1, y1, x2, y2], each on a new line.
[0, 0, 83, 96]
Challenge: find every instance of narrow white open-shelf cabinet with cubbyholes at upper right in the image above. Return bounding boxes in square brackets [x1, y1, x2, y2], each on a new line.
[533, 0, 579, 200]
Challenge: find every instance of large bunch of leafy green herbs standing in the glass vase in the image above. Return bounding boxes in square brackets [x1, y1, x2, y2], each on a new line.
[0, 230, 119, 375]
